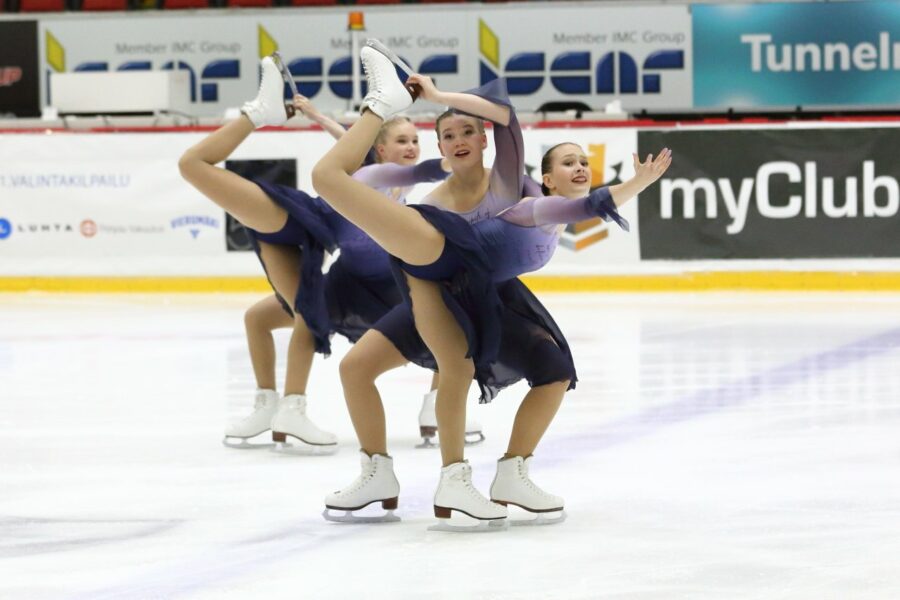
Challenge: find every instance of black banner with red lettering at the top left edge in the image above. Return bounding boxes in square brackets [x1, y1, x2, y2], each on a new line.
[0, 21, 41, 117]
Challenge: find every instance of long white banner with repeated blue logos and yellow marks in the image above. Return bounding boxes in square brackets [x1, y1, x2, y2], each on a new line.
[31, 3, 693, 116]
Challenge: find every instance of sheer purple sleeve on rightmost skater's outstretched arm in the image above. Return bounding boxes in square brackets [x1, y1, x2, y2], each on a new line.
[498, 187, 630, 231]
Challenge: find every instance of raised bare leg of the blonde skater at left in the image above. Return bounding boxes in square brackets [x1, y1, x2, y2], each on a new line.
[178, 115, 287, 233]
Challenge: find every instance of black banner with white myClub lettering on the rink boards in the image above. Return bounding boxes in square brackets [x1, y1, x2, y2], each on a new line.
[638, 128, 900, 260]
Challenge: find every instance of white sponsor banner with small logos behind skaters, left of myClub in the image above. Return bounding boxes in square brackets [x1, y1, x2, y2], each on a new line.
[0, 129, 639, 276]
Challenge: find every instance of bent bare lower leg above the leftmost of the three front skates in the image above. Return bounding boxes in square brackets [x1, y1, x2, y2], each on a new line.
[340, 329, 407, 456]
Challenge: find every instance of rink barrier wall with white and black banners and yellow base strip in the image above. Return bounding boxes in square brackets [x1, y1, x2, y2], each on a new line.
[0, 121, 900, 292]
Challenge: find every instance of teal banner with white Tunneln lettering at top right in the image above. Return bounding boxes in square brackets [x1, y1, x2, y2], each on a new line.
[692, 1, 900, 108]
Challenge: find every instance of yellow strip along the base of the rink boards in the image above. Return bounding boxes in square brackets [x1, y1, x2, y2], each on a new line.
[0, 271, 900, 293]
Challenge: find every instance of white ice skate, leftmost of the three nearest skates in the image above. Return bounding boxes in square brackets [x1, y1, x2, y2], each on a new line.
[322, 451, 400, 523]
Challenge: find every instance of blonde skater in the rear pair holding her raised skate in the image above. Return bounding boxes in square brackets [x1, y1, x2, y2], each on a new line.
[179, 57, 458, 447]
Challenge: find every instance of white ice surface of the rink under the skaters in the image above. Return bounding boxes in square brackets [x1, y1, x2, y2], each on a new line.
[0, 293, 900, 600]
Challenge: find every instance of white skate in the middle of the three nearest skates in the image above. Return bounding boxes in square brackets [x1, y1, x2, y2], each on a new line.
[428, 461, 508, 532]
